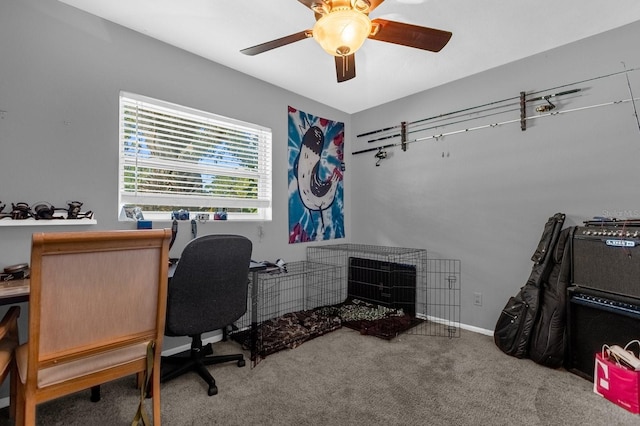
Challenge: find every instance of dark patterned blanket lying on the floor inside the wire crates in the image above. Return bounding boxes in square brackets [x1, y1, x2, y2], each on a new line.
[231, 299, 421, 358]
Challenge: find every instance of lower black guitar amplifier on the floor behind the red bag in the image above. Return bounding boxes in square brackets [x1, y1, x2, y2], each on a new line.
[565, 287, 640, 381]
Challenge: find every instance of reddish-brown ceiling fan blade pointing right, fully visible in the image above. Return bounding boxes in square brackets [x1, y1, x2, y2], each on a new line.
[369, 18, 452, 52]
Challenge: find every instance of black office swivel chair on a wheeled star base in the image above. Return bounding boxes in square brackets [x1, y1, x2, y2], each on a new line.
[160, 235, 252, 395]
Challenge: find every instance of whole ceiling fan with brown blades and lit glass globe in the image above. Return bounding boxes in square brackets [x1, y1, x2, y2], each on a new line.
[241, 0, 452, 83]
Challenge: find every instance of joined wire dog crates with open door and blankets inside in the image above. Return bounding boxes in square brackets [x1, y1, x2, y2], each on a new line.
[230, 244, 460, 366]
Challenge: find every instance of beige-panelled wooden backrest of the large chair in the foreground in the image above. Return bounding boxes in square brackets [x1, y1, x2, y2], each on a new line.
[27, 230, 170, 372]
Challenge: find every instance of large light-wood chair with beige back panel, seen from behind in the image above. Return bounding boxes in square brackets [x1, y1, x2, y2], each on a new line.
[16, 229, 171, 426]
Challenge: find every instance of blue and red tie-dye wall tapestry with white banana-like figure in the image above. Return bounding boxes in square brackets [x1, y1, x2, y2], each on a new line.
[288, 107, 345, 244]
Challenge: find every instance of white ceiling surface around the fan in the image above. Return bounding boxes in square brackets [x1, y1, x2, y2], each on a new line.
[60, 0, 640, 113]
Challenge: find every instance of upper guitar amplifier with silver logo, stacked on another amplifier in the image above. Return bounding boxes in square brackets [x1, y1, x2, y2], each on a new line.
[571, 226, 640, 298]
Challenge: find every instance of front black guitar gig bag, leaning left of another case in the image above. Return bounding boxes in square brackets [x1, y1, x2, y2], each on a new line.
[493, 213, 565, 358]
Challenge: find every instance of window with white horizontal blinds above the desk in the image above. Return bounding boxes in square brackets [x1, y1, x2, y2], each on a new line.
[119, 92, 271, 220]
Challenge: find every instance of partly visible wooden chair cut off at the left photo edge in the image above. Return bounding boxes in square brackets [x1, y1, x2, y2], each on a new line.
[0, 306, 20, 419]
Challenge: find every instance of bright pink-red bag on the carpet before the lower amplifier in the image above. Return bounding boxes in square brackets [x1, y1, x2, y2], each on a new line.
[593, 345, 640, 414]
